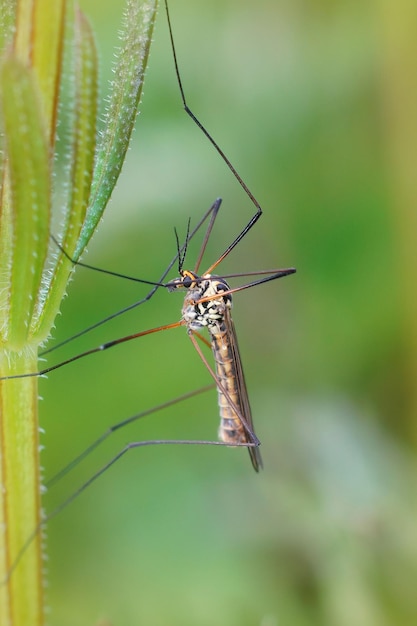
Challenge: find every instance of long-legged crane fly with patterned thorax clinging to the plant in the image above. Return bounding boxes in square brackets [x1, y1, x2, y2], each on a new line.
[0, 1, 296, 585]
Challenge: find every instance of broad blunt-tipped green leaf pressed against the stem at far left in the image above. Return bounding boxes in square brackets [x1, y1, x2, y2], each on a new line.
[0, 59, 50, 349]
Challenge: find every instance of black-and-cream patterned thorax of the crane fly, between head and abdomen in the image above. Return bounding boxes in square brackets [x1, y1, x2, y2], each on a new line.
[182, 272, 232, 333]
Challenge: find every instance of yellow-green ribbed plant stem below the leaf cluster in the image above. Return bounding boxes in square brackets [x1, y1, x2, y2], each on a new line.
[0, 352, 44, 626]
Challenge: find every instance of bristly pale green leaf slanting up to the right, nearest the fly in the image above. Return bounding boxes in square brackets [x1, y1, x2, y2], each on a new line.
[75, 0, 158, 258]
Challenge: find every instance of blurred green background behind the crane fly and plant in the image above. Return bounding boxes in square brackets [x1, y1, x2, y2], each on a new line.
[41, 0, 417, 626]
